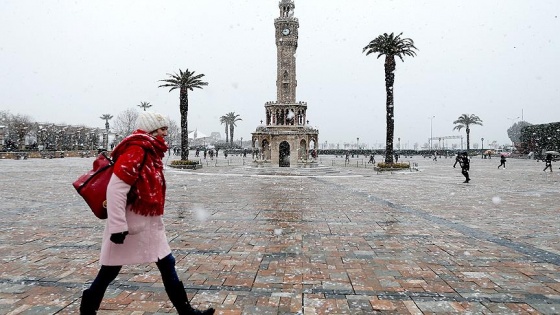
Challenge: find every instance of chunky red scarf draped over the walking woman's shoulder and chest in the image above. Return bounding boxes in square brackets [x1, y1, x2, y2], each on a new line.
[111, 130, 167, 216]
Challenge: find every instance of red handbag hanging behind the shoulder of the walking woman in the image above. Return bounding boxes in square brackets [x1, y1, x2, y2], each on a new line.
[72, 152, 114, 219]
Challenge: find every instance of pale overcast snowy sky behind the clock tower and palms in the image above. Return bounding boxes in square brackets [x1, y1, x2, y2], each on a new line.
[0, 0, 560, 148]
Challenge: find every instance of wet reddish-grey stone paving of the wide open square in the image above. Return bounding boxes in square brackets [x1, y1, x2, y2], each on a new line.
[0, 156, 560, 315]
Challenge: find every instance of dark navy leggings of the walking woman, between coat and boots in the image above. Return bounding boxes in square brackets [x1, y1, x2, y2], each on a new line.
[90, 254, 179, 295]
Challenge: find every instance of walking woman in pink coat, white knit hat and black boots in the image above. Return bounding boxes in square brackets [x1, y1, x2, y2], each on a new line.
[80, 112, 214, 315]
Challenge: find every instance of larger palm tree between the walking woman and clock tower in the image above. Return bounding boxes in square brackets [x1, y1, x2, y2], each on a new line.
[159, 69, 208, 160]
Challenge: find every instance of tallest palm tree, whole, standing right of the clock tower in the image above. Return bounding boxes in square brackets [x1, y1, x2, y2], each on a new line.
[362, 33, 417, 164]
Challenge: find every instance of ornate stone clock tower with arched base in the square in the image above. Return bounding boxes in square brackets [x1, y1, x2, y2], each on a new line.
[252, 0, 319, 167]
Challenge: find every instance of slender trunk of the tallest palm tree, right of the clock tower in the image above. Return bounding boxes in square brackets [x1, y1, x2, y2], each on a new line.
[385, 56, 395, 164]
